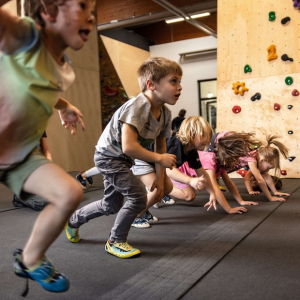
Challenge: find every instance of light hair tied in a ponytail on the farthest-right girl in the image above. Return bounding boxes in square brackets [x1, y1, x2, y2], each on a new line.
[258, 134, 289, 174]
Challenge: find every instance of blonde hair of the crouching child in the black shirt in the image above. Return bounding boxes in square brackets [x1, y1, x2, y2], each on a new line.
[176, 117, 213, 145]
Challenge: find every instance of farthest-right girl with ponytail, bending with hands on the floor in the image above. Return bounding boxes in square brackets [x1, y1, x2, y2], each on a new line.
[240, 135, 290, 202]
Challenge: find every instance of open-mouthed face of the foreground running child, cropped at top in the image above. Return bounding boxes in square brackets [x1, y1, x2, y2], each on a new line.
[53, 0, 95, 50]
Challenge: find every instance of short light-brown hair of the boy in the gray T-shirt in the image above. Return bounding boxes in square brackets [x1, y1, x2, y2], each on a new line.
[137, 57, 182, 92]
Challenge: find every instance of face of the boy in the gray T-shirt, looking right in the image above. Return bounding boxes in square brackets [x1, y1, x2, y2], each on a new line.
[153, 74, 182, 105]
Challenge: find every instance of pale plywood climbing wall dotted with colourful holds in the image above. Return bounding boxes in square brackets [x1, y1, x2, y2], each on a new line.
[217, 0, 300, 178]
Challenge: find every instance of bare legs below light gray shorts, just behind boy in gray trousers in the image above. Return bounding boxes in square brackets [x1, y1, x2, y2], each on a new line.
[137, 173, 173, 218]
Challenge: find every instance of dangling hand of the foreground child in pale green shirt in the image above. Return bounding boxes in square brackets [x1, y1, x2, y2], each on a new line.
[54, 97, 85, 135]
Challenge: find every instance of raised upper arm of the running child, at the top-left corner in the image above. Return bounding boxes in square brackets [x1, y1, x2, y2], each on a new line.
[0, 0, 31, 54]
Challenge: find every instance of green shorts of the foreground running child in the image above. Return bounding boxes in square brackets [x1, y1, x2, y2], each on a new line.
[0, 149, 51, 200]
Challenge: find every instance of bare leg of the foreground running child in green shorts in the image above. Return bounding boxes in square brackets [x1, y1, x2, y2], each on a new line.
[23, 163, 82, 268]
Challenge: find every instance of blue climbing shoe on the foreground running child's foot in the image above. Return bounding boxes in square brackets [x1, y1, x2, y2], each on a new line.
[14, 249, 70, 296]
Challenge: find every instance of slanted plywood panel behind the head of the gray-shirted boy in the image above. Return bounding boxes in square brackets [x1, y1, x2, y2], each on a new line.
[101, 36, 150, 97]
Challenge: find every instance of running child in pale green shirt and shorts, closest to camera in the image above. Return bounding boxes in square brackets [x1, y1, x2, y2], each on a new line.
[0, 0, 94, 294]
